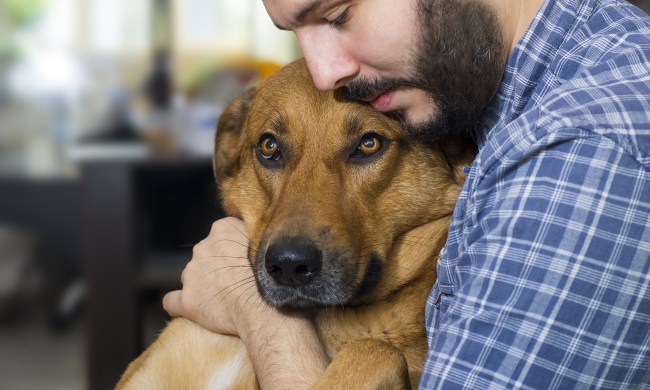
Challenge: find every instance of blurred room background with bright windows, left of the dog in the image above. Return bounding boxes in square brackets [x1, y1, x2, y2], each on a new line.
[0, 0, 650, 390]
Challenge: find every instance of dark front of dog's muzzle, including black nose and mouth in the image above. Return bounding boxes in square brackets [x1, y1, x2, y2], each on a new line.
[255, 237, 383, 308]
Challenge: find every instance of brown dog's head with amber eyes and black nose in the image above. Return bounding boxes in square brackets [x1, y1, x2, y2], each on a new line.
[214, 60, 472, 307]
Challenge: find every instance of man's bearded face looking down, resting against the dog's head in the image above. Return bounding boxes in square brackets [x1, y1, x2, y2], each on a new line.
[264, 0, 505, 139]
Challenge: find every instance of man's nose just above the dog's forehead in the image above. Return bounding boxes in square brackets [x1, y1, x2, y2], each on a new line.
[297, 31, 359, 91]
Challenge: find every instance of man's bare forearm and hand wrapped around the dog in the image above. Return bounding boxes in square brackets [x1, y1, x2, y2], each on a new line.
[163, 218, 329, 389]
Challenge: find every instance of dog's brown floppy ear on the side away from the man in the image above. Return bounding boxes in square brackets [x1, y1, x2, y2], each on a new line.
[213, 87, 255, 183]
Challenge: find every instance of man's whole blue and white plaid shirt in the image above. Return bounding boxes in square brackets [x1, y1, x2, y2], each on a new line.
[420, 0, 650, 390]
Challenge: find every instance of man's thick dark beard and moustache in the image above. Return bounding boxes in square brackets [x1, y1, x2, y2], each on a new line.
[344, 0, 506, 140]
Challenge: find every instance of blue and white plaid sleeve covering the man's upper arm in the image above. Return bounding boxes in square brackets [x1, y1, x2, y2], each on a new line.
[420, 131, 650, 389]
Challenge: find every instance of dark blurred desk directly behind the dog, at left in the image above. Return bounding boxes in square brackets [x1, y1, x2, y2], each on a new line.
[80, 152, 223, 389]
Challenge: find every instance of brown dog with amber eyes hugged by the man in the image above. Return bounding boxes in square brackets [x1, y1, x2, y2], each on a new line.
[118, 61, 474, 389]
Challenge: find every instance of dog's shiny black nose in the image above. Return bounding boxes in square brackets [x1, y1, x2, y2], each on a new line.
[264, 237, 323, 287]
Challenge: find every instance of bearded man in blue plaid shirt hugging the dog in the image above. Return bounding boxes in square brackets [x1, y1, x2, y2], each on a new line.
[164, 0, 650, 389]
